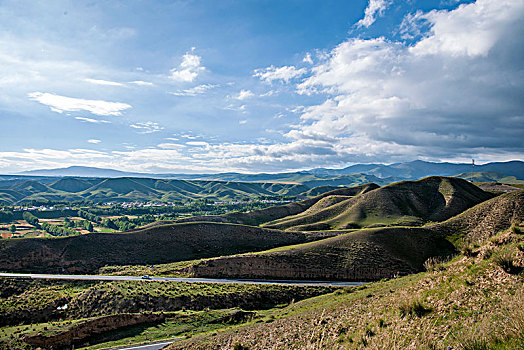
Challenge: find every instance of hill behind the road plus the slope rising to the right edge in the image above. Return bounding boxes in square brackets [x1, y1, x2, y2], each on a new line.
[177, 191, 524, 281]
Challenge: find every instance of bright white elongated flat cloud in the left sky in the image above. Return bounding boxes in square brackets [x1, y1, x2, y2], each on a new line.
[27, 92, 131, 116]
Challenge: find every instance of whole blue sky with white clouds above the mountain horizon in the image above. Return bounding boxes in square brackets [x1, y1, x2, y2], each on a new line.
[0, 0, 524, 174]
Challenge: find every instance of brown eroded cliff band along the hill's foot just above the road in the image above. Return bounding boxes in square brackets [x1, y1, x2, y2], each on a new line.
[183, 256, 415, 281]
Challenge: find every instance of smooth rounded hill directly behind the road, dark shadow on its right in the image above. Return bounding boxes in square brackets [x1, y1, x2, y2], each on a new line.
[182, 228, 455, 281]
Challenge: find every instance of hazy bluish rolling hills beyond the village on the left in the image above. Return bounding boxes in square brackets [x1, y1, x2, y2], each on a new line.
[0, 177, 320, 205]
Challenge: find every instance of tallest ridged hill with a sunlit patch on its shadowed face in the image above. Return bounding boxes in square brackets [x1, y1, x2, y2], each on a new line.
[265, 176, 492, 231]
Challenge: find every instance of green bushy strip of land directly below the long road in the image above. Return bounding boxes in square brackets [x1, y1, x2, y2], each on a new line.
[0, 278, 336, 328]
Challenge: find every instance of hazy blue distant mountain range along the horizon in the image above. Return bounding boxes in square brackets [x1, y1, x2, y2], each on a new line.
[16, 160, 524, 183]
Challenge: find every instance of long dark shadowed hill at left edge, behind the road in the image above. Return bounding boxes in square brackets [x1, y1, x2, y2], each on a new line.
[0, 222, 312, 273]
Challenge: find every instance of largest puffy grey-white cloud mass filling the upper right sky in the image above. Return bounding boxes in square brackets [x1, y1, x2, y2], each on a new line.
[287, 0, 524, 161]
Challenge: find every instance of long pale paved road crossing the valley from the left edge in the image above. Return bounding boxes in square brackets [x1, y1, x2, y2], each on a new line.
[0, 273, 365, 287]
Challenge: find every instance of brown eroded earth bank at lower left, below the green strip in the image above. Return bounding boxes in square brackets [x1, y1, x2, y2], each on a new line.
[24, 313, 165, 350]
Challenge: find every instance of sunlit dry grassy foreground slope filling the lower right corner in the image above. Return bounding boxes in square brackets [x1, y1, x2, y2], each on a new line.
[169, 226, 524, 350]
